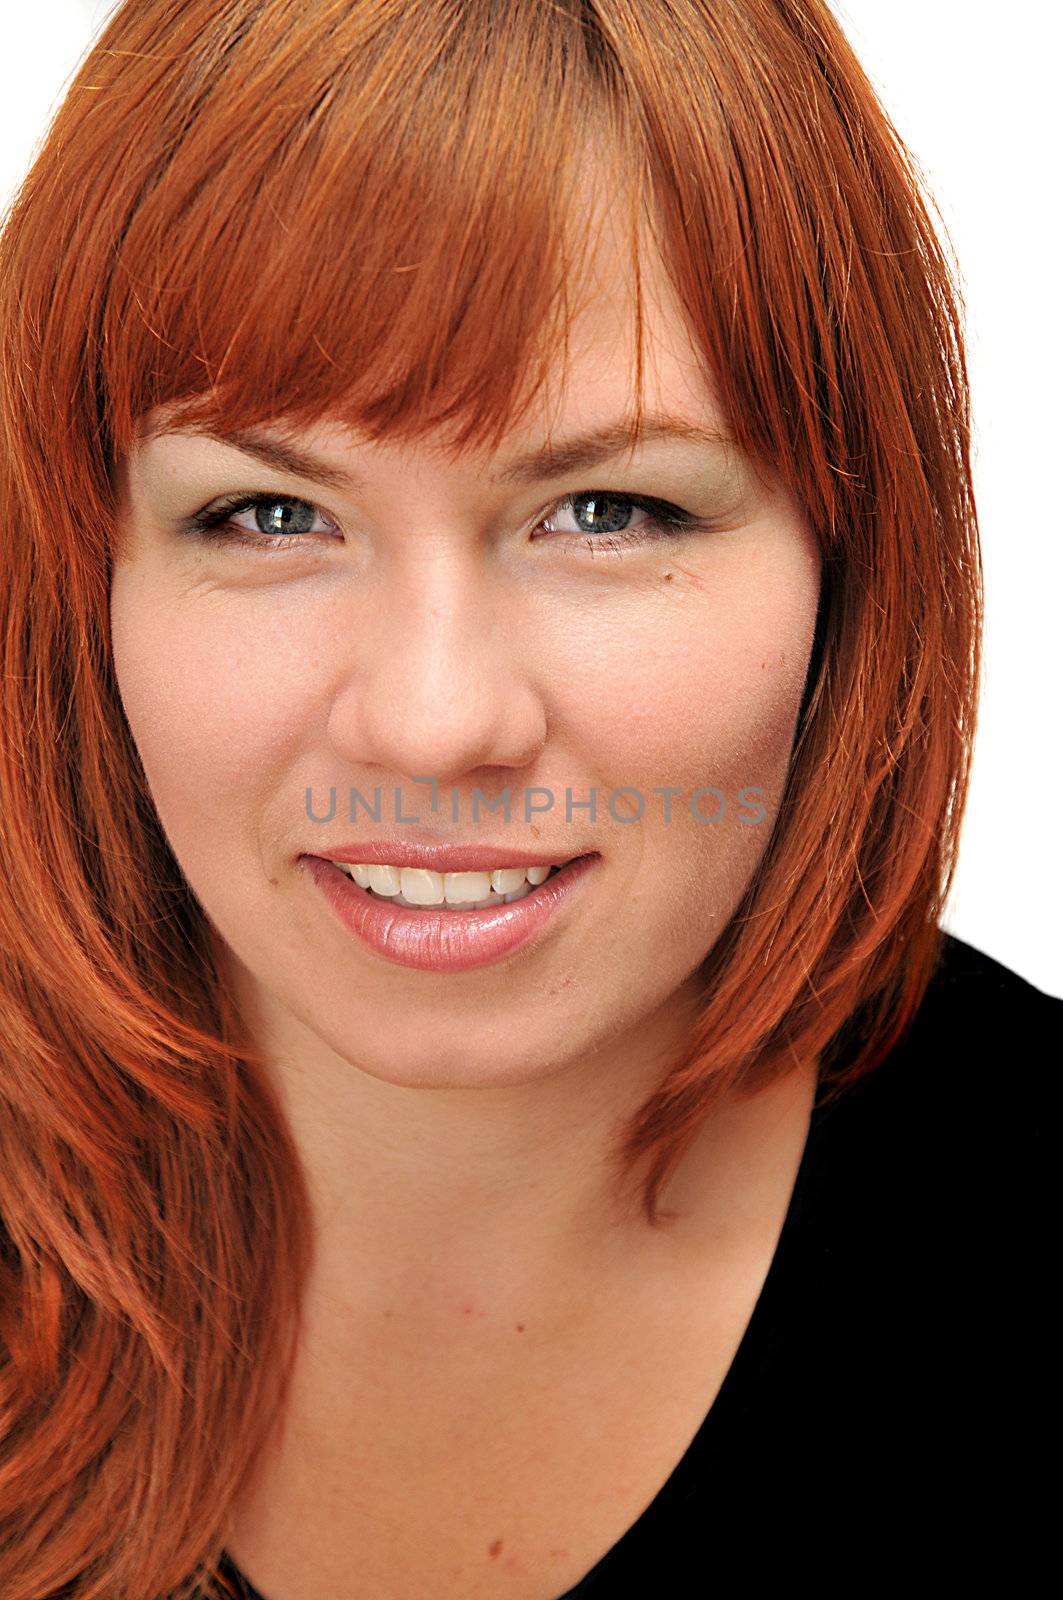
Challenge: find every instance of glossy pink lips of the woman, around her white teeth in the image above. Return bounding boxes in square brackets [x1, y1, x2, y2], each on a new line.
[299, 854, 600, 973]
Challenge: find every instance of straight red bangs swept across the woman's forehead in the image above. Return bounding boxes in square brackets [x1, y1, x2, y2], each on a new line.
[98, 0, 656, 473]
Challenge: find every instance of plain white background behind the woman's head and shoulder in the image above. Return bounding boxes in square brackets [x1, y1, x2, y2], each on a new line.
[0, 0, 1063, 995]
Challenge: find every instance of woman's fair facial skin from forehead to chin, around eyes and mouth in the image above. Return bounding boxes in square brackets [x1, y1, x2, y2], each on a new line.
[112, 206, 820, 1086]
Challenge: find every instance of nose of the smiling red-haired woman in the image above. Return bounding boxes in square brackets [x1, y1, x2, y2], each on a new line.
[328, 549, 546, 790]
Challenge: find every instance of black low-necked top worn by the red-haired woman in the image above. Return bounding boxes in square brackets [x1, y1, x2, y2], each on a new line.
[208, 934, 1063, 1600]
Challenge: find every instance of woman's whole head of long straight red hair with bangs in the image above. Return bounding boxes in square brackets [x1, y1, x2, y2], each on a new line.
[0, 0, 981, 1600]
